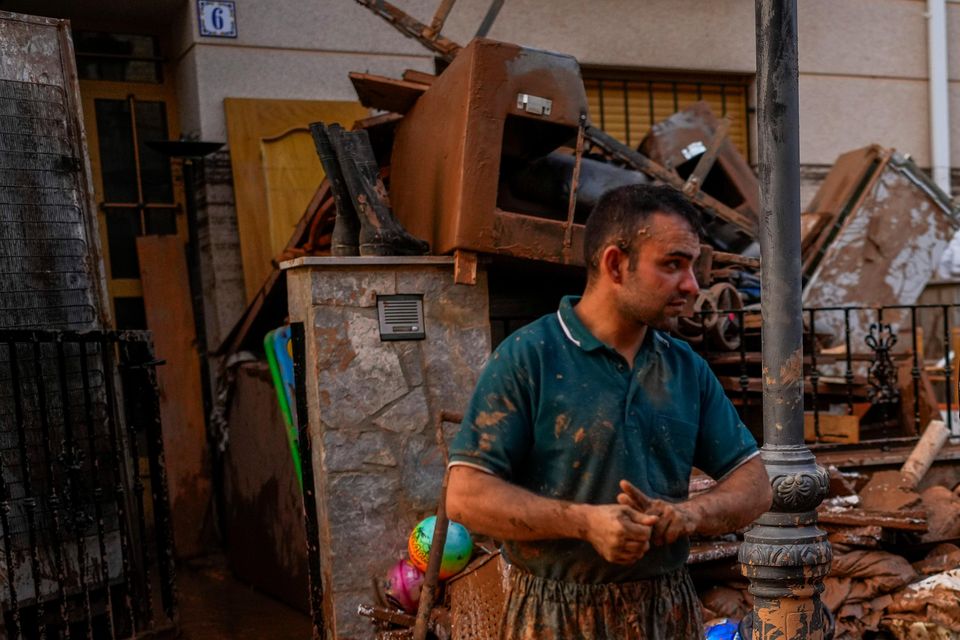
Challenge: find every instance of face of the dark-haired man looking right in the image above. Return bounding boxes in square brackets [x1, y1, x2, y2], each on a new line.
[617, 213, 700, 328]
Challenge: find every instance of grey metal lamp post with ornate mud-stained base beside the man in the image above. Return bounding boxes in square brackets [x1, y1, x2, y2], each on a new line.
[740, 0, 831, 640]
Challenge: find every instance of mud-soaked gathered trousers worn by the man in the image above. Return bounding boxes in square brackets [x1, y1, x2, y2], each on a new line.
[500, 567, 703, 640]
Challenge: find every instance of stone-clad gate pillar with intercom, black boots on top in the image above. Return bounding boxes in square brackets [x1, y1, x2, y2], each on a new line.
[284, 257, 490, 638]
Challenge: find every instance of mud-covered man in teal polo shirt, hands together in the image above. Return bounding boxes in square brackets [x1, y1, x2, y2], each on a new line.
[447, 185, 771, 640]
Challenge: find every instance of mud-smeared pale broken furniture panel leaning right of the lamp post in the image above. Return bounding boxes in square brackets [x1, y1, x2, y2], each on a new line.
[801, 145, 960, 348]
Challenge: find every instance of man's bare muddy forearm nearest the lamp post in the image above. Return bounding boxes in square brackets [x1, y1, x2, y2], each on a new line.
[686, 456, 772, 536]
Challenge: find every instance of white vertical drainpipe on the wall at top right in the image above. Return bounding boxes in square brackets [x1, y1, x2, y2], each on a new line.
[926, 0, 950, 194]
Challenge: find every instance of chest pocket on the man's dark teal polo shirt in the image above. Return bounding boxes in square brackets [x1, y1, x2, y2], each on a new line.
[646, 413, 698, 501]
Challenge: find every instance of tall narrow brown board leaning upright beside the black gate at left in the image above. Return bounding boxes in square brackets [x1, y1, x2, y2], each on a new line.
[137, 236, 210, 557]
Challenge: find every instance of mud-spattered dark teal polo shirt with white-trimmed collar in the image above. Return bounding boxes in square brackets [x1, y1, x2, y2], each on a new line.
[450, 297, 757, 583]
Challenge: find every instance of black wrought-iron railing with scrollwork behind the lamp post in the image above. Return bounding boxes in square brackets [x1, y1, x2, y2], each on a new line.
[681, 304, 960, 443]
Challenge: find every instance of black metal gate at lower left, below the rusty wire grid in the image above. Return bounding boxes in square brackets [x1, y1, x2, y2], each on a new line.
[0, 330, 176, 639]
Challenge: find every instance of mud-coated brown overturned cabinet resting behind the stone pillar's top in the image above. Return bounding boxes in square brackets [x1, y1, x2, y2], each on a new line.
[390, 38, 587, 264]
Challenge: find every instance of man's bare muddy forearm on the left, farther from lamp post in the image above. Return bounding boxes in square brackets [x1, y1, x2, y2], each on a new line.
[446, 466, 587, 540]
